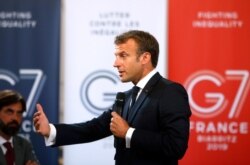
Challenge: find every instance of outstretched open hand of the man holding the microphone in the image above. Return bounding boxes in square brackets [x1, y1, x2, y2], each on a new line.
[33, 104, 50, 138]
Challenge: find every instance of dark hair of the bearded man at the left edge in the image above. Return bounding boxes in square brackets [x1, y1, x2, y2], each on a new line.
[0, 89, 26, 111]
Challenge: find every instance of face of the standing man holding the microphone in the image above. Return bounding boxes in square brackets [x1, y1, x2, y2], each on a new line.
[113, 39, 143, 84]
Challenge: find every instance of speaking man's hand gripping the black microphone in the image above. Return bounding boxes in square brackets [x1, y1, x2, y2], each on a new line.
[110, 112, 129, 138]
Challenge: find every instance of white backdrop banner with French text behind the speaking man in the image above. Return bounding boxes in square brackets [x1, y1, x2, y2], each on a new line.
[62, 0, 167, 165]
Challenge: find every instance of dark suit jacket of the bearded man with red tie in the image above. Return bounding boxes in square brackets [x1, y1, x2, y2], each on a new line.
[0, 136, 39, 165]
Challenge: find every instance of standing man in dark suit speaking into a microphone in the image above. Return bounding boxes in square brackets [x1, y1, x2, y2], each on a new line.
[33, 30, 191, 165]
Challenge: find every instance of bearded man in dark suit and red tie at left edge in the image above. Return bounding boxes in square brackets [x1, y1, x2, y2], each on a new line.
[0, 90, 39, 165]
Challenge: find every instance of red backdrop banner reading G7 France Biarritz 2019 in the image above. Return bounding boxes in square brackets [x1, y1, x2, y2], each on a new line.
[169, 0, 250, 165]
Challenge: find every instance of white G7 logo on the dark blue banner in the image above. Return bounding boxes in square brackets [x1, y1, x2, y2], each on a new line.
[0, 69, 46, 117]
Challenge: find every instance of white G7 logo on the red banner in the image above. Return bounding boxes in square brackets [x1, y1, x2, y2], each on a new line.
[185, 70, 250, 118]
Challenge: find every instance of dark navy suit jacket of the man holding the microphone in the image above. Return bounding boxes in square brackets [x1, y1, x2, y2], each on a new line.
[55, 73, 191, 165]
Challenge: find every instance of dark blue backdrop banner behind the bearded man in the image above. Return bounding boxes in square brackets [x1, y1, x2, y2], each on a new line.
[0, 0, 60, 165]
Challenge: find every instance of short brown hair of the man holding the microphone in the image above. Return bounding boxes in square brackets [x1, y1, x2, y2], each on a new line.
[114, 30, 159, 67]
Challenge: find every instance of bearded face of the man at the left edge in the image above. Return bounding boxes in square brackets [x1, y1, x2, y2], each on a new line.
[0, 103, 23, 136]
